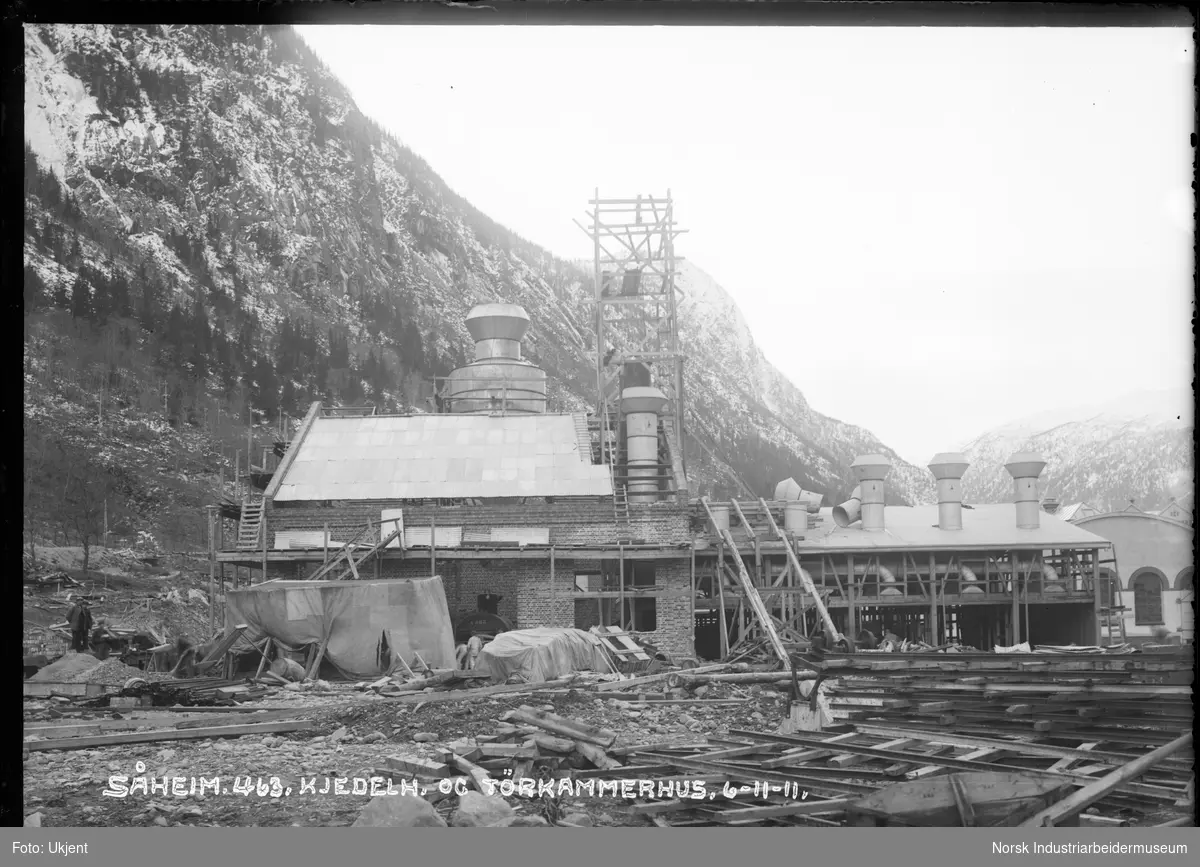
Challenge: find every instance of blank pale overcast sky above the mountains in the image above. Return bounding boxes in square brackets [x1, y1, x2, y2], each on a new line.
[299, 25, 1193, 464]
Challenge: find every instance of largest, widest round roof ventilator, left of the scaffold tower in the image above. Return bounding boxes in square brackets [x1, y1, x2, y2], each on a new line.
[444, 304, 546, 414]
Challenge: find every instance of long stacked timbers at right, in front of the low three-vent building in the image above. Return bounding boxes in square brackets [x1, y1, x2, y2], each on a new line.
[826, 653, 1193, 748]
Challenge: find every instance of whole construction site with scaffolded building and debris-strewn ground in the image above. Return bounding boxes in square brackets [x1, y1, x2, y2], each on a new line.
[25, 191, 1195, 826]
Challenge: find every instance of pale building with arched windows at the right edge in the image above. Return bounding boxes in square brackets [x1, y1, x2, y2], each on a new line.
[1072, 509, 1195, 641]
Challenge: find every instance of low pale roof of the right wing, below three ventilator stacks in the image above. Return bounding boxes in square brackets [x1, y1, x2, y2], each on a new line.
[797, 503, 1109, 552]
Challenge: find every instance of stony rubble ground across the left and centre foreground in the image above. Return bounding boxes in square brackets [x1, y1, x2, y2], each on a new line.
[25, 683, 786, 826]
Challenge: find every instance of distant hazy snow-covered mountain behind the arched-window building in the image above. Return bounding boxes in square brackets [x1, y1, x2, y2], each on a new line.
[962, 389, 1195, 509]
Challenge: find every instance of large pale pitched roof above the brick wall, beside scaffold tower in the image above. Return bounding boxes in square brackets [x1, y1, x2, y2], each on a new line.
[275, 414, 612, 502]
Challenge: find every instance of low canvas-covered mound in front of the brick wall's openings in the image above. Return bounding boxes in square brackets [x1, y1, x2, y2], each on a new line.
[475, 627, 608, 683]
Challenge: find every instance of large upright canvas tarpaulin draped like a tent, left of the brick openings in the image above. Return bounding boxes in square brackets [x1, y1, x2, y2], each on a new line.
[226, 576, 455, 680]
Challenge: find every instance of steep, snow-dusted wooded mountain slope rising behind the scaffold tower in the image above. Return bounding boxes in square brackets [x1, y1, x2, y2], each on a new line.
[25, 25, 930, 525]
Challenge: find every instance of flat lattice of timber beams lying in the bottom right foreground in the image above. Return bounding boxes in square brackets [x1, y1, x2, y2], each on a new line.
[628, 724, 1195, 827]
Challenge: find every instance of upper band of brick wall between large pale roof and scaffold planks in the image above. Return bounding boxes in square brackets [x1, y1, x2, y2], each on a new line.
[266, 498, 689, 545]
